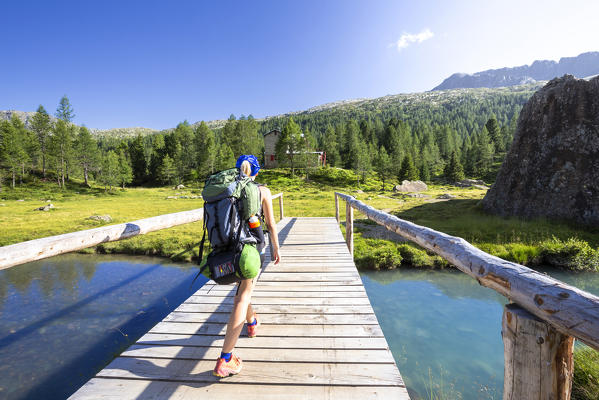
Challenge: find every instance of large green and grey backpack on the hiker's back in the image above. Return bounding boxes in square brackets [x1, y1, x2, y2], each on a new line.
[199, 168, 261, 284]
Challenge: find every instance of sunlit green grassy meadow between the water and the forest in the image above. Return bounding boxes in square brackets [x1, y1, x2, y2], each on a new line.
[0, 168, 599, 270]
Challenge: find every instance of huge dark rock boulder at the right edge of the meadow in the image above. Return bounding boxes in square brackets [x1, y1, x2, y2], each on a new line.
[482, 75, 599, 224]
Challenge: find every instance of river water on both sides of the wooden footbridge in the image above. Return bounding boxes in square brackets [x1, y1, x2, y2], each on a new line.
[0, 254, 599, 400]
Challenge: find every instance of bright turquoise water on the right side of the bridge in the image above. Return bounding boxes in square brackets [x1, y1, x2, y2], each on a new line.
[361, 270, 599, 400]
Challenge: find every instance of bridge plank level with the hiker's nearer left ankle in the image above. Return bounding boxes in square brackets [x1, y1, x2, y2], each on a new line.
[121, 345, 394, 364]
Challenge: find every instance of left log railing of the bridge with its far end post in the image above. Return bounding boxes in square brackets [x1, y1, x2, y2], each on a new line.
[0, 193, 284, 270]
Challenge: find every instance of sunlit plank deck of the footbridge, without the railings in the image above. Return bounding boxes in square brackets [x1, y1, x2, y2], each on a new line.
[71, 218, 409, 399]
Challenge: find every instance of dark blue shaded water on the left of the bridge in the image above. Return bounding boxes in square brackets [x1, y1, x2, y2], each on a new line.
[0, 255, 204, 399]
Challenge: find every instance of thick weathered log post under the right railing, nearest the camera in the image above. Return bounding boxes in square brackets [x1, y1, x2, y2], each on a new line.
[501, 303, 574, 400]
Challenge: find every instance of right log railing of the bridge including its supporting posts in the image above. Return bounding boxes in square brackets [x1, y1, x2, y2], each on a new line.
[335, 192, 599, 399]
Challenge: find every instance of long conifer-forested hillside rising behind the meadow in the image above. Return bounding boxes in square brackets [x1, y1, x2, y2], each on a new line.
[0, 83, 541, 187]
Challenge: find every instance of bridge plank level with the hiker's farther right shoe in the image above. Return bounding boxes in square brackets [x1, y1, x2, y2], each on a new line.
[149, 322, 383, 337]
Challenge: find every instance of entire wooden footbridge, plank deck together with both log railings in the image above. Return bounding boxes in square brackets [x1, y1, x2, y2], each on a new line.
[0, 193, 599, 400]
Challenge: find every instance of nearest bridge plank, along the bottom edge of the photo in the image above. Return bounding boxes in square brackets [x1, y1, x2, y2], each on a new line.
[71, 378, 410, 400]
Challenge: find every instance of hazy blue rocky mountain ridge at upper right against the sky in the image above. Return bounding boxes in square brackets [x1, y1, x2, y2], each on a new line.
[433, 51, 599, 90]
